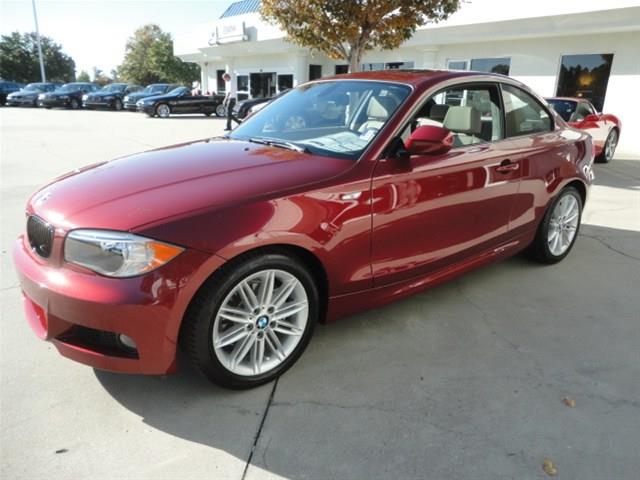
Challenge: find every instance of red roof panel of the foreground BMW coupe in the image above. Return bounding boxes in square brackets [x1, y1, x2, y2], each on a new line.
[316, 69, 509, 87]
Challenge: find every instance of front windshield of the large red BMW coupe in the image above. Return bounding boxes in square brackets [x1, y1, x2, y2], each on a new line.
[229, 80, 411, 159]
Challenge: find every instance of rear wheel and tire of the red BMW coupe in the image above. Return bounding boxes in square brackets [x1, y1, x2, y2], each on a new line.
[530, 187, 582, 264]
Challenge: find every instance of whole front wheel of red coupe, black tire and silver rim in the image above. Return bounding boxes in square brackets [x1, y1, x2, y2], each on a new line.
[180, 253, 319, 389]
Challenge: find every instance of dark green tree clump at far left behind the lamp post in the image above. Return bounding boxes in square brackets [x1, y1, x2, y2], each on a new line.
[0, 32, 76, 83]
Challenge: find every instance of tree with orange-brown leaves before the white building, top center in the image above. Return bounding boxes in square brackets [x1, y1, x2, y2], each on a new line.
[261, 0, 461, 72]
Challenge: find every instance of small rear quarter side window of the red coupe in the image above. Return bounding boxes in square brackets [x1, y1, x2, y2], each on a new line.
[502, 84, 552, 137]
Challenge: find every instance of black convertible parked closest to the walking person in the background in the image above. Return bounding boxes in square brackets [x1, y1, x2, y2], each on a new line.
[136, 87, 224, 118]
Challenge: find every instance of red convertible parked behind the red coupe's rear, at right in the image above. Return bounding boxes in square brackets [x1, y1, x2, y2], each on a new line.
[547, 97, 622, 163]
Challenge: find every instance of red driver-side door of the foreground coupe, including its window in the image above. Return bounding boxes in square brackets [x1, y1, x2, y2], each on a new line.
[372, 83, 521, 285]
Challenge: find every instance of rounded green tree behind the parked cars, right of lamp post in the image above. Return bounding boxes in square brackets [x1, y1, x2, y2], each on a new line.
[118, 24, 200, 85]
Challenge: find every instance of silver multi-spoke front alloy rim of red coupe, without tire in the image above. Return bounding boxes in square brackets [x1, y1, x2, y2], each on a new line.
[212, 269, 309, 376]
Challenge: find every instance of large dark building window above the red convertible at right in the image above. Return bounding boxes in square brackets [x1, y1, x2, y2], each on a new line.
[556, 53, 613, 112]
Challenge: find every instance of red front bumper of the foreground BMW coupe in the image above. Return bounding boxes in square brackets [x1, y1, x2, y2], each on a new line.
[13, 236, 223, 374]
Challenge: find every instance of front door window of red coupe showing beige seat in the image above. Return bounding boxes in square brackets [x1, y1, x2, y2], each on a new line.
[402, 84, 504, 147]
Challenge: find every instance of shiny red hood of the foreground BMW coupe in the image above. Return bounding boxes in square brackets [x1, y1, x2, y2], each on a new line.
[27, 138, 354, 234]
